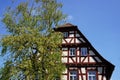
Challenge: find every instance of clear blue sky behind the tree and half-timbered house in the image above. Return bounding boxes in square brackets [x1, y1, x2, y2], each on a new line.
[0, 0, 120, 80]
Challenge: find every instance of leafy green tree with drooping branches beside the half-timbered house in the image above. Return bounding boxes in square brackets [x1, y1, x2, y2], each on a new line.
[1, 0, 65, 80]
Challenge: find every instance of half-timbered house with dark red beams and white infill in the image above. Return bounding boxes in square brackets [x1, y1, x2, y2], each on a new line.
[55, 23, 114, 80]
